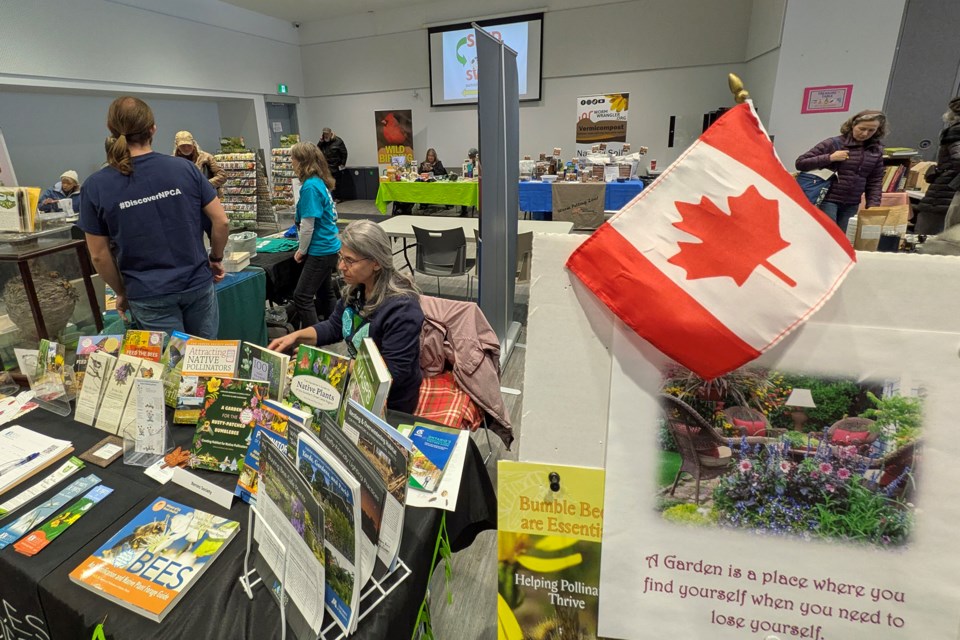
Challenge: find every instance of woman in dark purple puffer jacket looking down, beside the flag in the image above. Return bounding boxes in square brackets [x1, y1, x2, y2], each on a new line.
[796, 109, 887, 232]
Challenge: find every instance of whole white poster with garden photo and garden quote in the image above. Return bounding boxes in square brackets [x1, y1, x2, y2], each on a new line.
[599, 316, 960, 640]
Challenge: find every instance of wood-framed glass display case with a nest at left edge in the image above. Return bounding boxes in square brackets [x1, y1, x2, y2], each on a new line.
[0, 224, 103, 370]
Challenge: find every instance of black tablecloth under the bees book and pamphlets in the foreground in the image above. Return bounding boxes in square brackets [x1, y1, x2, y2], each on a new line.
[0, 409, 496, 640]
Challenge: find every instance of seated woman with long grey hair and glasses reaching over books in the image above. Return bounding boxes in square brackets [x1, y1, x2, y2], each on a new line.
[268, 220, 423, 413]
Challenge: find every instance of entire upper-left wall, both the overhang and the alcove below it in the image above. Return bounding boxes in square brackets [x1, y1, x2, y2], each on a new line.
[0, 0, 303, 186]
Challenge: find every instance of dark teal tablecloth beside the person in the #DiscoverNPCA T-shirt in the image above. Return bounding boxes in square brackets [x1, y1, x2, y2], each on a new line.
[103, 267, 267, 346]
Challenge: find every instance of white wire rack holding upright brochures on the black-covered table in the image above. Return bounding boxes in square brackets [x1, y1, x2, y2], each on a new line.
[239, 505, 411, 640]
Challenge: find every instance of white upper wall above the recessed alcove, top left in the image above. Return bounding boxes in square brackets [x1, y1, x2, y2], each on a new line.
[0, 0, 302, 94]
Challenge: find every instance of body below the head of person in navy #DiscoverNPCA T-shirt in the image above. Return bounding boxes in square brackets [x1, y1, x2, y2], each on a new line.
[77, 136, 228, 339]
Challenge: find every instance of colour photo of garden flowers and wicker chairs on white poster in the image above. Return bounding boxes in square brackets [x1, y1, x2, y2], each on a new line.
[655, 367, 924, 548]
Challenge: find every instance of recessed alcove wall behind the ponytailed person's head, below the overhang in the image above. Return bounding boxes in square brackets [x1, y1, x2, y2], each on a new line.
[0, 90, 220, 188]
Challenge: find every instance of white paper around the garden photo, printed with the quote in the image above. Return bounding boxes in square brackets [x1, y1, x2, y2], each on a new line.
[599, 318, 960, 640]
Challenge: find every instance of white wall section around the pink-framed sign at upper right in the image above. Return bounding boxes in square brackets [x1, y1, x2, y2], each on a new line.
[768, 0, 905, 168]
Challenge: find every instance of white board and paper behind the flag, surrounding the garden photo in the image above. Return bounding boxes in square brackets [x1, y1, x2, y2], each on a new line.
[520, 236, 960, 640]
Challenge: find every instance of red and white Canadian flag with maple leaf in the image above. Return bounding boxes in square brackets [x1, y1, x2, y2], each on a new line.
[567, 102, 856, 379]
